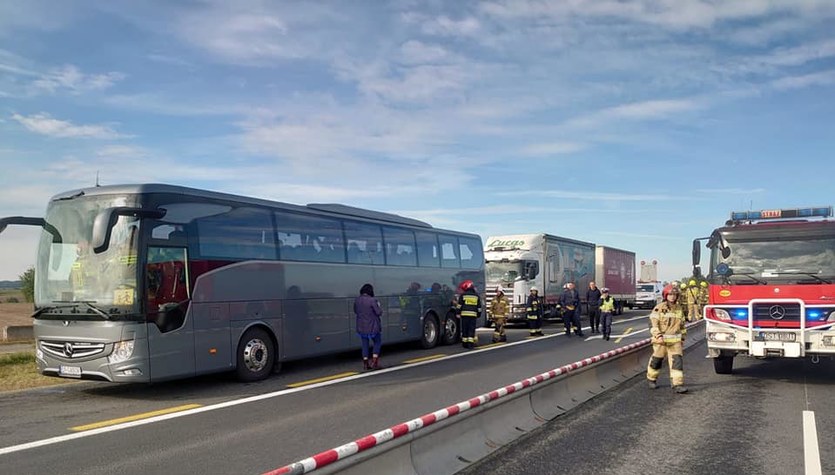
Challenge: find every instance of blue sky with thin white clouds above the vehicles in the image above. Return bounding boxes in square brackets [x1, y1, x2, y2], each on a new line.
[0, 0, 835, 280]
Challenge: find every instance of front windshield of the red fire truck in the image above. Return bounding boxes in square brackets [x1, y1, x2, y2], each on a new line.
[711, 237, 835, 283]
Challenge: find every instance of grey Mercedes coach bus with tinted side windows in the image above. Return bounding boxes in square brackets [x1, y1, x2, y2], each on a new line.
[0, 184, 484, 382]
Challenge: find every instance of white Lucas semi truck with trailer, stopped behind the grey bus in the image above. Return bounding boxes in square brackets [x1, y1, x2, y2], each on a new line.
[484, 233, 635, 322]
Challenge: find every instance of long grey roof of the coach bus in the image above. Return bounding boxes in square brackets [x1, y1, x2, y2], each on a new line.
[50, 183, 480, 239]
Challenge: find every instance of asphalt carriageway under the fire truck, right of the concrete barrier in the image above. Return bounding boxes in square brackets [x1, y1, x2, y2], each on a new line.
[459, 342, 835, 475]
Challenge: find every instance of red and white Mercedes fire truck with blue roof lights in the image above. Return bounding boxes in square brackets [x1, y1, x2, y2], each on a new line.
[693, 206, 835, 374]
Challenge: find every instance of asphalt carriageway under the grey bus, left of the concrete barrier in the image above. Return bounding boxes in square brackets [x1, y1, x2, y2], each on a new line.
[0, 312, 646, 475]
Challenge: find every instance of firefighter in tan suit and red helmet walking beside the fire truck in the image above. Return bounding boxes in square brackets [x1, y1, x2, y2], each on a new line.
[647, 285, 687, 394]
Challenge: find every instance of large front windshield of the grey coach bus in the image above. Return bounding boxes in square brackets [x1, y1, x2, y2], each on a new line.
[35, 196, 140, 320]
